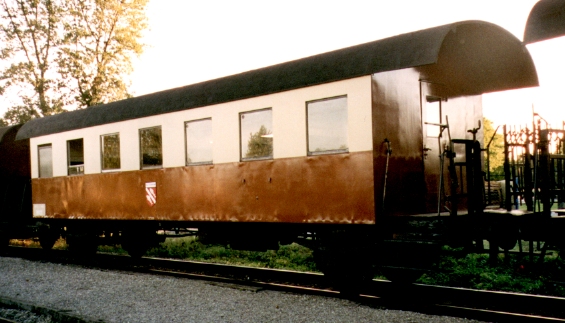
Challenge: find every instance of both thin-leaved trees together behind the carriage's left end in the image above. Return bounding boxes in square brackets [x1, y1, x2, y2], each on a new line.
[0, 0, 148, 124]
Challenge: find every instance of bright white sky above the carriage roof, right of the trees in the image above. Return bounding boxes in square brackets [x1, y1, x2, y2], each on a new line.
[131, 0, 565, 128]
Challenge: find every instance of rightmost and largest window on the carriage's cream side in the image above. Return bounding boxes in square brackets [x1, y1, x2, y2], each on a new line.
[306, 96, 349, 155]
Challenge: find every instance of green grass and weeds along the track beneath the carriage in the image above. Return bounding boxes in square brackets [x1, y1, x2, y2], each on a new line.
[7, 237, 565, 297]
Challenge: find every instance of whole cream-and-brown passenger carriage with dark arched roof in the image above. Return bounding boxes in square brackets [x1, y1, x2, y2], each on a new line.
[1, 21, 538, 276]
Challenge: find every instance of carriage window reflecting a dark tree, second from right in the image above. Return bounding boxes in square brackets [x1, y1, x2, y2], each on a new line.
[239, 109, 273, 160]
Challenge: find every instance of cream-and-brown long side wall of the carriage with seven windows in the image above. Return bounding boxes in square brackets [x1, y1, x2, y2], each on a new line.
[30, 77, 374, 227]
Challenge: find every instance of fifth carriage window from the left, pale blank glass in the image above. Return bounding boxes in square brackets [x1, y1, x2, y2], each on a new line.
[185, 119, 212, 165]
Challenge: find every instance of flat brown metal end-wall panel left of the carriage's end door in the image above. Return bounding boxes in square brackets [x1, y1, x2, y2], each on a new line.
[372, 69, 425, 218]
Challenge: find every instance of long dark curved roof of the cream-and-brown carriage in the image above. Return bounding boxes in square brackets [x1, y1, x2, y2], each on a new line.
[18, 21, 537, 139]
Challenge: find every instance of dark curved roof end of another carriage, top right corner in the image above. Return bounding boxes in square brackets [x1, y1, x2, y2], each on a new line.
[524, 0, 565, 44]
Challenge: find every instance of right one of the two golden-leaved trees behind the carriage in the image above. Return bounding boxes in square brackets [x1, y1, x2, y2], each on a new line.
[58, 0, 148, 107]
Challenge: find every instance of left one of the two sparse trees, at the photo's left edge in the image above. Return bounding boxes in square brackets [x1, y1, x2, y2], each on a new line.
[0, 0, 65, 123]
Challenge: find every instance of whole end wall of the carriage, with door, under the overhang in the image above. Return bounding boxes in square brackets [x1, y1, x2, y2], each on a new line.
[372, 68, 482, 218]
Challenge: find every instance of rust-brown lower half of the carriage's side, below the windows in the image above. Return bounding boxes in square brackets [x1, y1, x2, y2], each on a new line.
[32, 152, 375, 224]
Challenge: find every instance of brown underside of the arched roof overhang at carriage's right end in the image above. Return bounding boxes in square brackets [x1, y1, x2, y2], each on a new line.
[420, 24, 538, 98]
